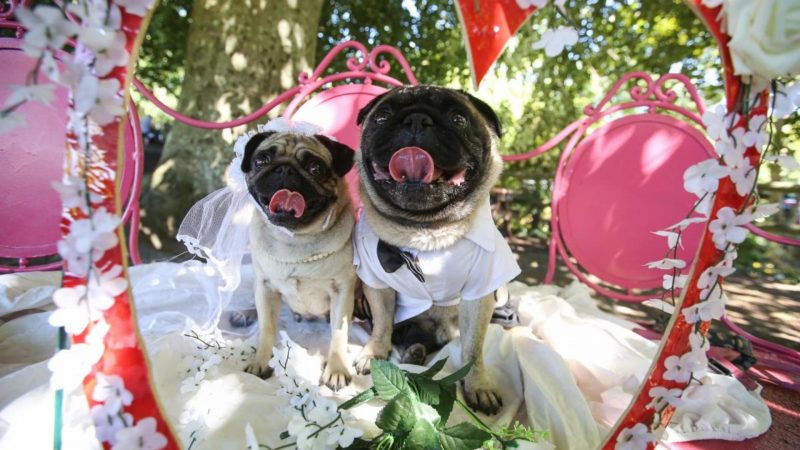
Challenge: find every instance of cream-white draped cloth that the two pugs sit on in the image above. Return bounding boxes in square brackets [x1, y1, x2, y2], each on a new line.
[0, 262, 771, 450]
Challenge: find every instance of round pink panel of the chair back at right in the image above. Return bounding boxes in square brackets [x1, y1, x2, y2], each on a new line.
[555, 114, 713, 288]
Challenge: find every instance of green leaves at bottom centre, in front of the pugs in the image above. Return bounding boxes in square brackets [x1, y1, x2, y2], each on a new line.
[339, 359, 546, 450]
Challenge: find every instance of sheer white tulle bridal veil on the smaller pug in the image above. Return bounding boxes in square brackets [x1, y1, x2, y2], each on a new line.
[177, 117, 322, 328]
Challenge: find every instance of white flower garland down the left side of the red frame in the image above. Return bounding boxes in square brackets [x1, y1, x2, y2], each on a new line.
[0, 0, 167, 450]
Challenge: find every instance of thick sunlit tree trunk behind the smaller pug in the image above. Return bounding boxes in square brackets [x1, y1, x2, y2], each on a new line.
[141, 0, 322, 250]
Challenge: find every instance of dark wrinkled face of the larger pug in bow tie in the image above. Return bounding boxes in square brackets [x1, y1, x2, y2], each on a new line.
[358, 86, 500, 216]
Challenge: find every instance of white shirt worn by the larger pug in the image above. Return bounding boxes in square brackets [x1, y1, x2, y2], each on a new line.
[353, 202, 521, 323]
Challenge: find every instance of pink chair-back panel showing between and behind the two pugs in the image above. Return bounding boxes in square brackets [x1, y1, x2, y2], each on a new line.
[292, 84, 386, 211]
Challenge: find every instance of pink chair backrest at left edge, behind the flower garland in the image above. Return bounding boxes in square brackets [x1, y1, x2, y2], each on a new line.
[0, 38, 143, 273]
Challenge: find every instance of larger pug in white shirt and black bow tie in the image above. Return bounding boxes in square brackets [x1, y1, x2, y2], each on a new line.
[354, 86, 520, 414]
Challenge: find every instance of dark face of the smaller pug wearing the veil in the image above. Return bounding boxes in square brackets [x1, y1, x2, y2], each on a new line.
[242, 132, 353, 230]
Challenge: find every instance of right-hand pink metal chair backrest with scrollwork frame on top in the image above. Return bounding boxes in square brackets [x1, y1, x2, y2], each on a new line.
[510, 72, 714, 301]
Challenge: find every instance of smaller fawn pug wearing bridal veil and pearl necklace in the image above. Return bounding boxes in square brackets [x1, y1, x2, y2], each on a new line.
[241, 132, 357, 390]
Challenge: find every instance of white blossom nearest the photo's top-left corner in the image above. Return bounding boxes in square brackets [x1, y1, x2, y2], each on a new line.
[15, 5, 77, 58]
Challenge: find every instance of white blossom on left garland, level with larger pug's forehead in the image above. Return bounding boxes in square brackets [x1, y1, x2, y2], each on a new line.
[74, 74, 125, 126]
